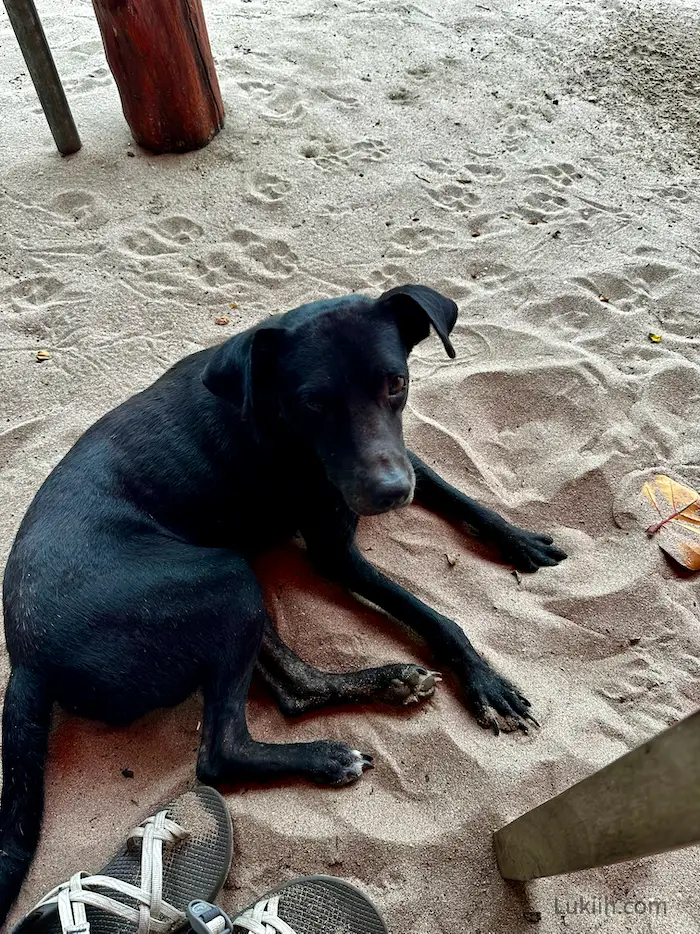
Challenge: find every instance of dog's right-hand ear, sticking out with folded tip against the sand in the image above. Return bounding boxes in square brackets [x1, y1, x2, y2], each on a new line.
[377, 285, 458, 358]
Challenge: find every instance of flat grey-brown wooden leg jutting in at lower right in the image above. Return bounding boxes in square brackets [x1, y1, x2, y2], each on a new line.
[494, 712, 700, 881]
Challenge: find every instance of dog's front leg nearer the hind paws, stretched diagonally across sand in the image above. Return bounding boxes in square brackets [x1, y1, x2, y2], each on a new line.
[307, 538, 536, 733]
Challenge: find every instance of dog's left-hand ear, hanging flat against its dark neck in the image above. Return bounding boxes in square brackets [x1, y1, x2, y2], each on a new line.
[202, 320, 280, 419]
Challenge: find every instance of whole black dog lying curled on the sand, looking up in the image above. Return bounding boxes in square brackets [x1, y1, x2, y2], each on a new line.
[0, 285, 566, 919]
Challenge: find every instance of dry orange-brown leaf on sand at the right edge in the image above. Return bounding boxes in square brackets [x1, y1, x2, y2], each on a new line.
[642, 474, 700, 571]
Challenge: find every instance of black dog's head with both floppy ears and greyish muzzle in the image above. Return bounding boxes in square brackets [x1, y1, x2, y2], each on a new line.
[202, 285, 457, 515]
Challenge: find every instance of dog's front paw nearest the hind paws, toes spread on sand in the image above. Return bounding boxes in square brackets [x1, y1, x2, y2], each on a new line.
[465, 662, 539, 736]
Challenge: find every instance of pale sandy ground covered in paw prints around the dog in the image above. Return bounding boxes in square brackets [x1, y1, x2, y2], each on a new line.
[0, 0, 700, 934]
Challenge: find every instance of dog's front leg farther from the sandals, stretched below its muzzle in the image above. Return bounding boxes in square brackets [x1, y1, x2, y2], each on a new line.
[408, 451, 566, 571]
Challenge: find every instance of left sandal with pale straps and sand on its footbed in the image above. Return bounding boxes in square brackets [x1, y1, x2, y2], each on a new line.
[12, 785, 233, 934]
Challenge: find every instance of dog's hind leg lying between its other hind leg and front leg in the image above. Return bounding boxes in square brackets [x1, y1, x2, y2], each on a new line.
[257, 622, 441, 716]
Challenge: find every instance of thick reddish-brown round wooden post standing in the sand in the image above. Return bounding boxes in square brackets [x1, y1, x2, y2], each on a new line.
[93, 0, 224, 153]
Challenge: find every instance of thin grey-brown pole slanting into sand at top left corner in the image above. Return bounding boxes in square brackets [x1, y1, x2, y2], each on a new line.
[5, 0, 80, 156]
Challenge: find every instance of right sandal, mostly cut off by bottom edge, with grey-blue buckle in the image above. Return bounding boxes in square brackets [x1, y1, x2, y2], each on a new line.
[187, 876, 388, 934]
